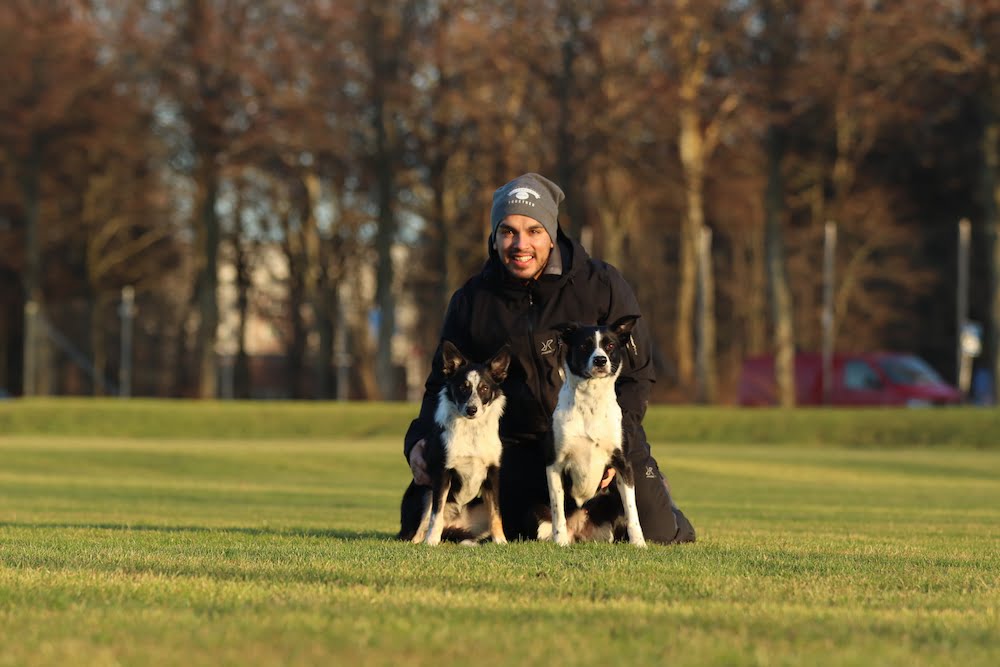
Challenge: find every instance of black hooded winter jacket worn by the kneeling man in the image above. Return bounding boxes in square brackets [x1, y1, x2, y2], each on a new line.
[403, 230, 654, 468]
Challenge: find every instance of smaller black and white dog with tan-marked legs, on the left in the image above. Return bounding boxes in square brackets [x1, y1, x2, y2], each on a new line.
[398, 341, 510, 545]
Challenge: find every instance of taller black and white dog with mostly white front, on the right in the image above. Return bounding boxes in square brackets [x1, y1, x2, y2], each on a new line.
[539, 315, 646, 547]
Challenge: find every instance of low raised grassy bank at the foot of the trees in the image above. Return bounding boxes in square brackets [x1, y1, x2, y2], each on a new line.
[0, 398, 1000, 449]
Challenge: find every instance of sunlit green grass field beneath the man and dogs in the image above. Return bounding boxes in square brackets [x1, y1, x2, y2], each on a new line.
[0, 402, 1000, 667]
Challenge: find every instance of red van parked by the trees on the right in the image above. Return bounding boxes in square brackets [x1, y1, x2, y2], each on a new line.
[739, 352, 962, 407]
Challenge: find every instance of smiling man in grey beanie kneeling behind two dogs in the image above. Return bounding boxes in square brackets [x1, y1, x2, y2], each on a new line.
[403, 174, 695, 544]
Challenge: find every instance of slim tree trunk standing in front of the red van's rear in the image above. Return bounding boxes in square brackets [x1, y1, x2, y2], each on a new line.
[764, 127, 795, 407]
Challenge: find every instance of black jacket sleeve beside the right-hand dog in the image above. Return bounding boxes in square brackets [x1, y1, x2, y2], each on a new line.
[607, 265, 656, 463]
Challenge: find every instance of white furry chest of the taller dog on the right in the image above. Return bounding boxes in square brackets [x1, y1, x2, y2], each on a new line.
[552, 379, 622, 504]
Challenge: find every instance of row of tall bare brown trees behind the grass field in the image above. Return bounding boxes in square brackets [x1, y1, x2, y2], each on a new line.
[0, 0, 1000, 403]
